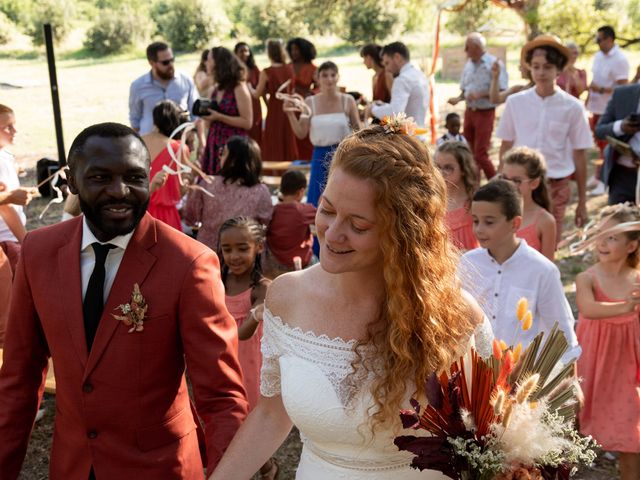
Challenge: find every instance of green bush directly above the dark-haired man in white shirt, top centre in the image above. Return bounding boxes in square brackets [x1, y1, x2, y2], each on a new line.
[339, 0, 399, 43]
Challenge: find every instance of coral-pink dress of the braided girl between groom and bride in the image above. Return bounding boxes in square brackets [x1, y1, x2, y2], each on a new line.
[224, 288, 262, 410]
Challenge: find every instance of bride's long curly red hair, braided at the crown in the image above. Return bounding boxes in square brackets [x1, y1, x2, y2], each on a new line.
[329, 126, 474, 430]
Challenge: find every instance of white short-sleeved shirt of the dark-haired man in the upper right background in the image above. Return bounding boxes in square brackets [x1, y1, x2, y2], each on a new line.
[587, 45, 629, 115]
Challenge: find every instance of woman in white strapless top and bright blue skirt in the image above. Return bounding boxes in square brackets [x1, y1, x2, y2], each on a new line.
[285, 62, 360, 206]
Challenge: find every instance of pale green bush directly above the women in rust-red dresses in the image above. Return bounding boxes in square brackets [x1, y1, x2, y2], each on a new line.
[236, 0, 308, 42]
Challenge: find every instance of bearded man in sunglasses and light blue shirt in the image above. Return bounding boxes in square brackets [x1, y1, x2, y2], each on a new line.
[129, 42, 198, 135]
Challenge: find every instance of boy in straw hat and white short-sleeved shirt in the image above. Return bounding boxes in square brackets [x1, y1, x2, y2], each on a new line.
[496, 35, 593, 241]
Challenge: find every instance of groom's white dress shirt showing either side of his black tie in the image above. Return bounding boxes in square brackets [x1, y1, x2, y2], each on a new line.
[80, 218, 135, 303]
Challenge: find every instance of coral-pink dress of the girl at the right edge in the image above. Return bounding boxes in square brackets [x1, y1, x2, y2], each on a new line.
[576, 274, 640, 453]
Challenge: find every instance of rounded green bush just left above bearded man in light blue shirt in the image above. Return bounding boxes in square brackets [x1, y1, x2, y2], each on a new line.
[84, 7, 155, 55]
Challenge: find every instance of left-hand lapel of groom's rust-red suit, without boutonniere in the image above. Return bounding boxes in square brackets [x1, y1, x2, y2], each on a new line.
[57, 217, 87, 368]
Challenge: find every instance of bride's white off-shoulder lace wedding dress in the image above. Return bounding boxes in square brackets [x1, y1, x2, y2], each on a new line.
[260, 308, 493, 480]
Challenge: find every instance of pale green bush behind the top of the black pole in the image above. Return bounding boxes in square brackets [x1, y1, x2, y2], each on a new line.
[26, 0, 75, 45]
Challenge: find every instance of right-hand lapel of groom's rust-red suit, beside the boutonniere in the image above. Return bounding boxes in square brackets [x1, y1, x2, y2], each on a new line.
[83, 213, 156, 379]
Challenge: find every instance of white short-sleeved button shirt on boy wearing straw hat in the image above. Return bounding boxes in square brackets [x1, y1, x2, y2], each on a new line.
[496, 87, 593, 179]
